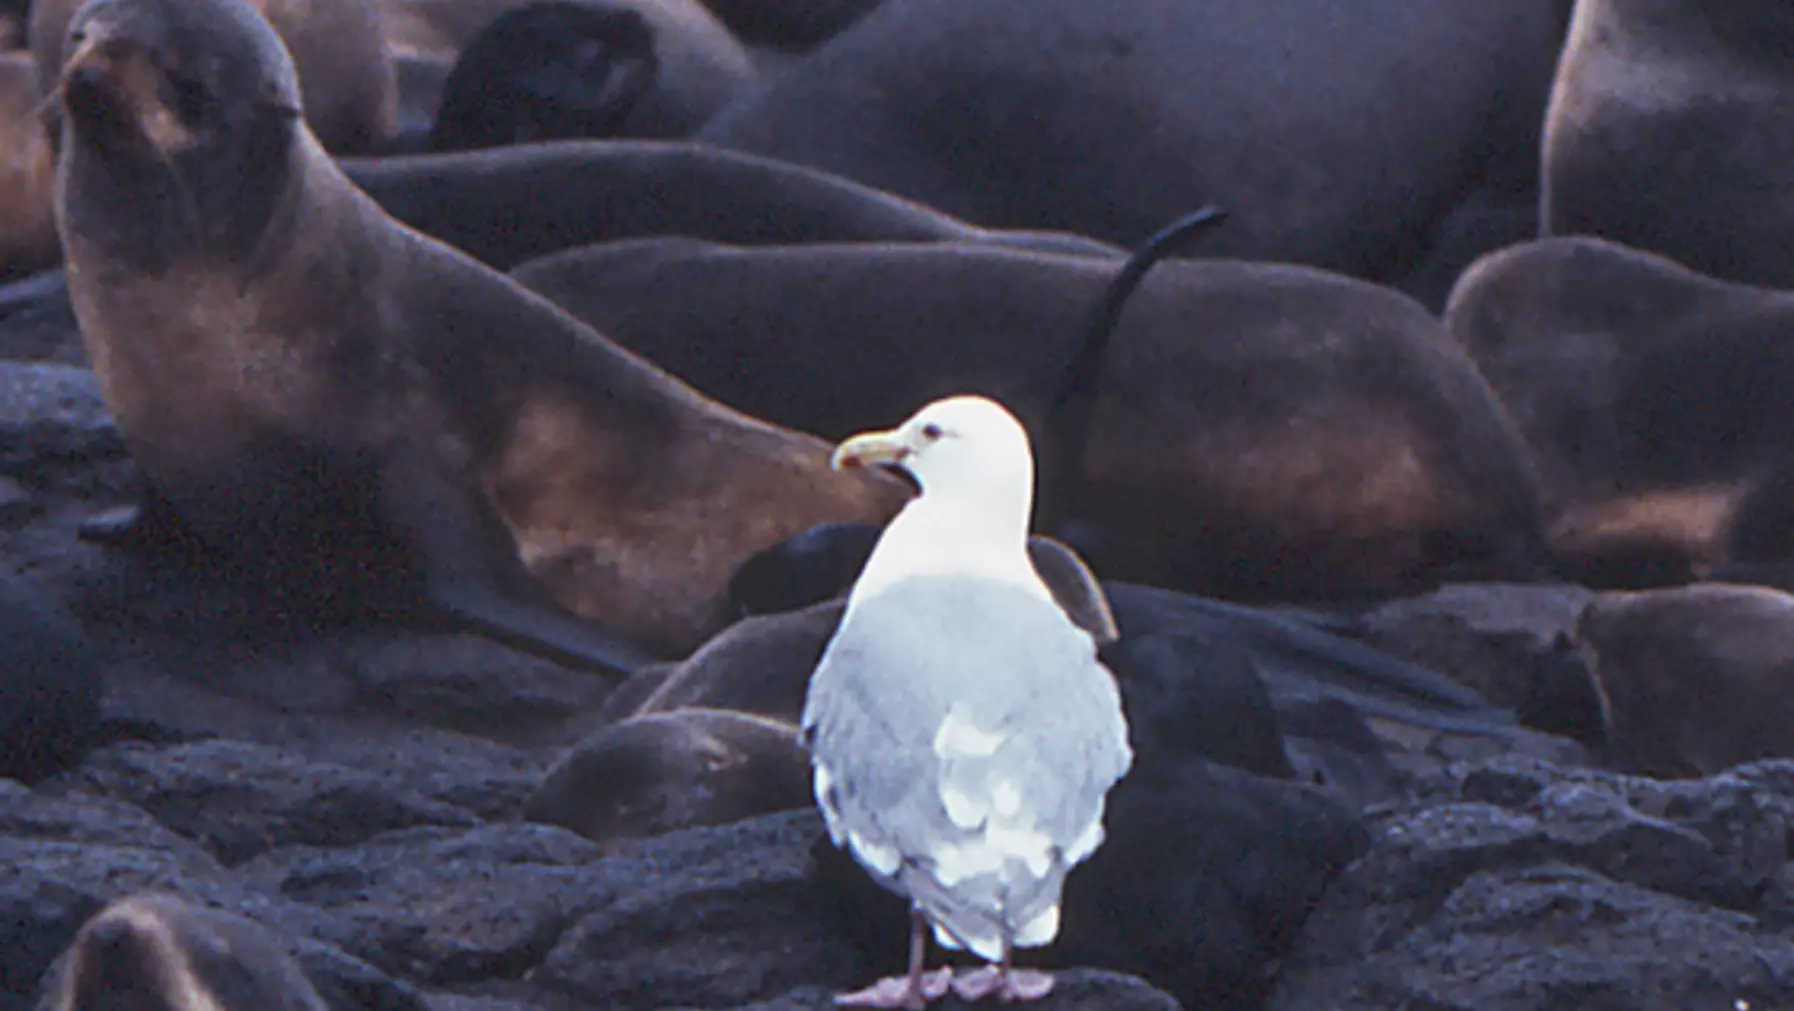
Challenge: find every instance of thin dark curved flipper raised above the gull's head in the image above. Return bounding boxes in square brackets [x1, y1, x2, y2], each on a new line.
[1035, 206, 1227, 547]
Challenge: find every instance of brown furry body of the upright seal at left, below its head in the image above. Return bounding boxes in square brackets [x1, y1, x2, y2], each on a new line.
[59, 0, 906, 656]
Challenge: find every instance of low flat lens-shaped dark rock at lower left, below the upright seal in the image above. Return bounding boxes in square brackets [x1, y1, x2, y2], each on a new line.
[52, 740, 479, 864]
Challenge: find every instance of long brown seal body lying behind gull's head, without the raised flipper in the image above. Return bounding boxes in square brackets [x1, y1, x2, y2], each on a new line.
[515, 236, 1537, 599]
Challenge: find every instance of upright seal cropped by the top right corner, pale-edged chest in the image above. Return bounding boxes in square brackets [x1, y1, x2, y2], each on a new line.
[1541, 0, 1794, 289]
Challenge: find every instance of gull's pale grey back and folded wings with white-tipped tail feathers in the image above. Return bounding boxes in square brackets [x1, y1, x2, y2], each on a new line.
[804, 575, 1132, 959]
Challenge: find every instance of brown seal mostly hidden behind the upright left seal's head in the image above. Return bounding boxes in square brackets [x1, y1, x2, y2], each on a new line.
[30, 0, 398, 154]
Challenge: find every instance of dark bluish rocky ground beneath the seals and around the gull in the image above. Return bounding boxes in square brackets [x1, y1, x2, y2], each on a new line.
[0, 277, 1794, 1011]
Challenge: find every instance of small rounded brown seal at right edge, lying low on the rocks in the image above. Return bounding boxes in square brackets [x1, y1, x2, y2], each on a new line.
[1577, 583, 1794, 776]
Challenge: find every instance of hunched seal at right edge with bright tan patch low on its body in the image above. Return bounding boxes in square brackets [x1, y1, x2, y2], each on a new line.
[1446, 237, 1794, 588]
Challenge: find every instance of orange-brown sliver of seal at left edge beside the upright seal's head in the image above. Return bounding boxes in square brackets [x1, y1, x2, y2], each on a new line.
[0, 52, 61, 278]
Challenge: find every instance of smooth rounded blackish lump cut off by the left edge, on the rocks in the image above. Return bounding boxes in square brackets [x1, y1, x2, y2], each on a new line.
[0, 572, 100, 782]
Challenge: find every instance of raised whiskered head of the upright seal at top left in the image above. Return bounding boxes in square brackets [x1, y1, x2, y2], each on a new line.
[57, 0, 305, 271]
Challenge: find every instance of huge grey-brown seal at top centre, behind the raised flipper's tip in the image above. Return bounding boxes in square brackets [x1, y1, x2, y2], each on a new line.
[698, 0, 1568, 293]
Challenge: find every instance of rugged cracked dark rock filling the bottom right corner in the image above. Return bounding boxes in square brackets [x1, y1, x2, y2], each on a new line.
[1270, 758, 1794, 1011]
